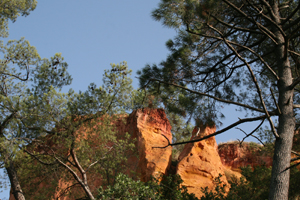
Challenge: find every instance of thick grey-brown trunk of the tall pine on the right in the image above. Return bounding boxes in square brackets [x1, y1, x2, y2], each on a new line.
[269, 1, 295, 200]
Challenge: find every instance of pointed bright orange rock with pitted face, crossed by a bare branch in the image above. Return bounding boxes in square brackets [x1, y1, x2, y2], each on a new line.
[177, 126, 228, 198]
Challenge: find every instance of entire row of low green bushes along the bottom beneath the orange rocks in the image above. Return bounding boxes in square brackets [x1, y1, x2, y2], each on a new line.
[98, 166, 300, 200]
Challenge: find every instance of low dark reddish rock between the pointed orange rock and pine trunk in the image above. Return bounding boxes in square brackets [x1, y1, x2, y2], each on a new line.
[218, 141, 272, 172]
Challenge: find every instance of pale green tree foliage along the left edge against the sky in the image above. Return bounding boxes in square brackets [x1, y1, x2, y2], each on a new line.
[0, 0, 72, 198]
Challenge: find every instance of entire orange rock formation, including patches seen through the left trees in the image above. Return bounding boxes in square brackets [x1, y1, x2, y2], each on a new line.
[10, 108, 284, 200]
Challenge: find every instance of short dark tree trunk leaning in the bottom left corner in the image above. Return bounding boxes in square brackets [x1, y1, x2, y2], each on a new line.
[5, 160, 25, 200]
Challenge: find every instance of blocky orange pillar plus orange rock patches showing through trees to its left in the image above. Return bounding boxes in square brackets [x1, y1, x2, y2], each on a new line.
[9, 108, 172, 200]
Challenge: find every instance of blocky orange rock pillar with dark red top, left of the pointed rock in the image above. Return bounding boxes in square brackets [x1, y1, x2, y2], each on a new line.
[127, 108, 172, 182]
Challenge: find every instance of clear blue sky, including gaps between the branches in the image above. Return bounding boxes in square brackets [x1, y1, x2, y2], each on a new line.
[0, 0, 262, 200]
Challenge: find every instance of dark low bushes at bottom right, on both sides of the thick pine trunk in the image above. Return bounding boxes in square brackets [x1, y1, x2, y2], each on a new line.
[201, 166, 300, 200]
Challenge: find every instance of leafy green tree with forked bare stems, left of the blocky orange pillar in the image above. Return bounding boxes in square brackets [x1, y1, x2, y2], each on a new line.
[15, 62, 137, 199]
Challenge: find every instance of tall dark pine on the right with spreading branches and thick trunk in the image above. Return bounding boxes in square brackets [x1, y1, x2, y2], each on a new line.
[140, 0, 300, 200]
